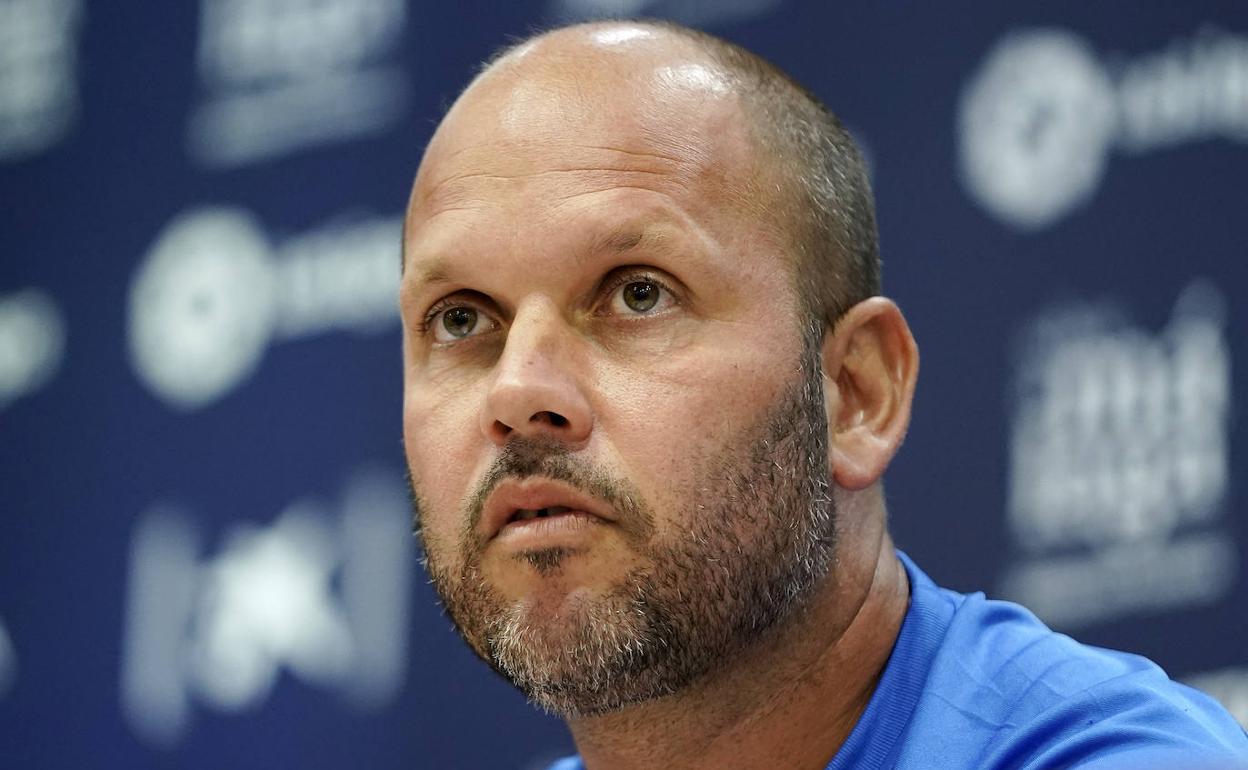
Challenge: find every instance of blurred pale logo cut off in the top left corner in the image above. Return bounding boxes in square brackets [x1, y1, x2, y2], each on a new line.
[0, 0, 82, 160]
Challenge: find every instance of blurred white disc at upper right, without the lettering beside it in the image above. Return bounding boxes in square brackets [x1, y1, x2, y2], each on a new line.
[958, 30, 1117, 230]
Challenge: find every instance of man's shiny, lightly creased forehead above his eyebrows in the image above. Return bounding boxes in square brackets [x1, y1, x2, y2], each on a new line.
[408, 39, 758, 238]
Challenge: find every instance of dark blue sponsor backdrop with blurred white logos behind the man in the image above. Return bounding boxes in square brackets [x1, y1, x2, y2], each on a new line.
[0, 0, 1248, 770]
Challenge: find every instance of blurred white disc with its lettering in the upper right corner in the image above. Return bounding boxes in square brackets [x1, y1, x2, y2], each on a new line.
[957, 29, 1248, 230]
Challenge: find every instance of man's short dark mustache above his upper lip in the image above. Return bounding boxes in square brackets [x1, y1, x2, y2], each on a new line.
[464, 438, 654, 542]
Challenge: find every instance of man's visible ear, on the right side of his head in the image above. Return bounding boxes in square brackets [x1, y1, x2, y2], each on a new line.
[821, 297, 919, 489]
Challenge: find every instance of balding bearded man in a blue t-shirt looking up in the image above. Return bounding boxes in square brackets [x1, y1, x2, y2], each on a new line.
[401, 21, 1248, 770]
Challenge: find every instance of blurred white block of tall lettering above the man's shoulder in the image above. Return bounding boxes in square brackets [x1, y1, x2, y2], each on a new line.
[1001, 281, 1239, 628]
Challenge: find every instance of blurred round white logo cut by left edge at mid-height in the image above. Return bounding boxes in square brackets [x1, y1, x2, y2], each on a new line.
[0, 288, 65, 408]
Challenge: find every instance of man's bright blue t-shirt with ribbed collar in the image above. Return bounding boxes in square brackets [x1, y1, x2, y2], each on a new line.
[550, 552, 1248, 770]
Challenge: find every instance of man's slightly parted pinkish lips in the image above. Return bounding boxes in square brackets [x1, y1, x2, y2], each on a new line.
[478, 478, 615, 539]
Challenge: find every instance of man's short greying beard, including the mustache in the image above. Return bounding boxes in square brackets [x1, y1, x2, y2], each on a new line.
[413, 339, 836, 719]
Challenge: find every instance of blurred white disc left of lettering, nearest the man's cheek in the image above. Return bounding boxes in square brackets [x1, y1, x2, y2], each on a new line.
[130, 208, 273, 409]
